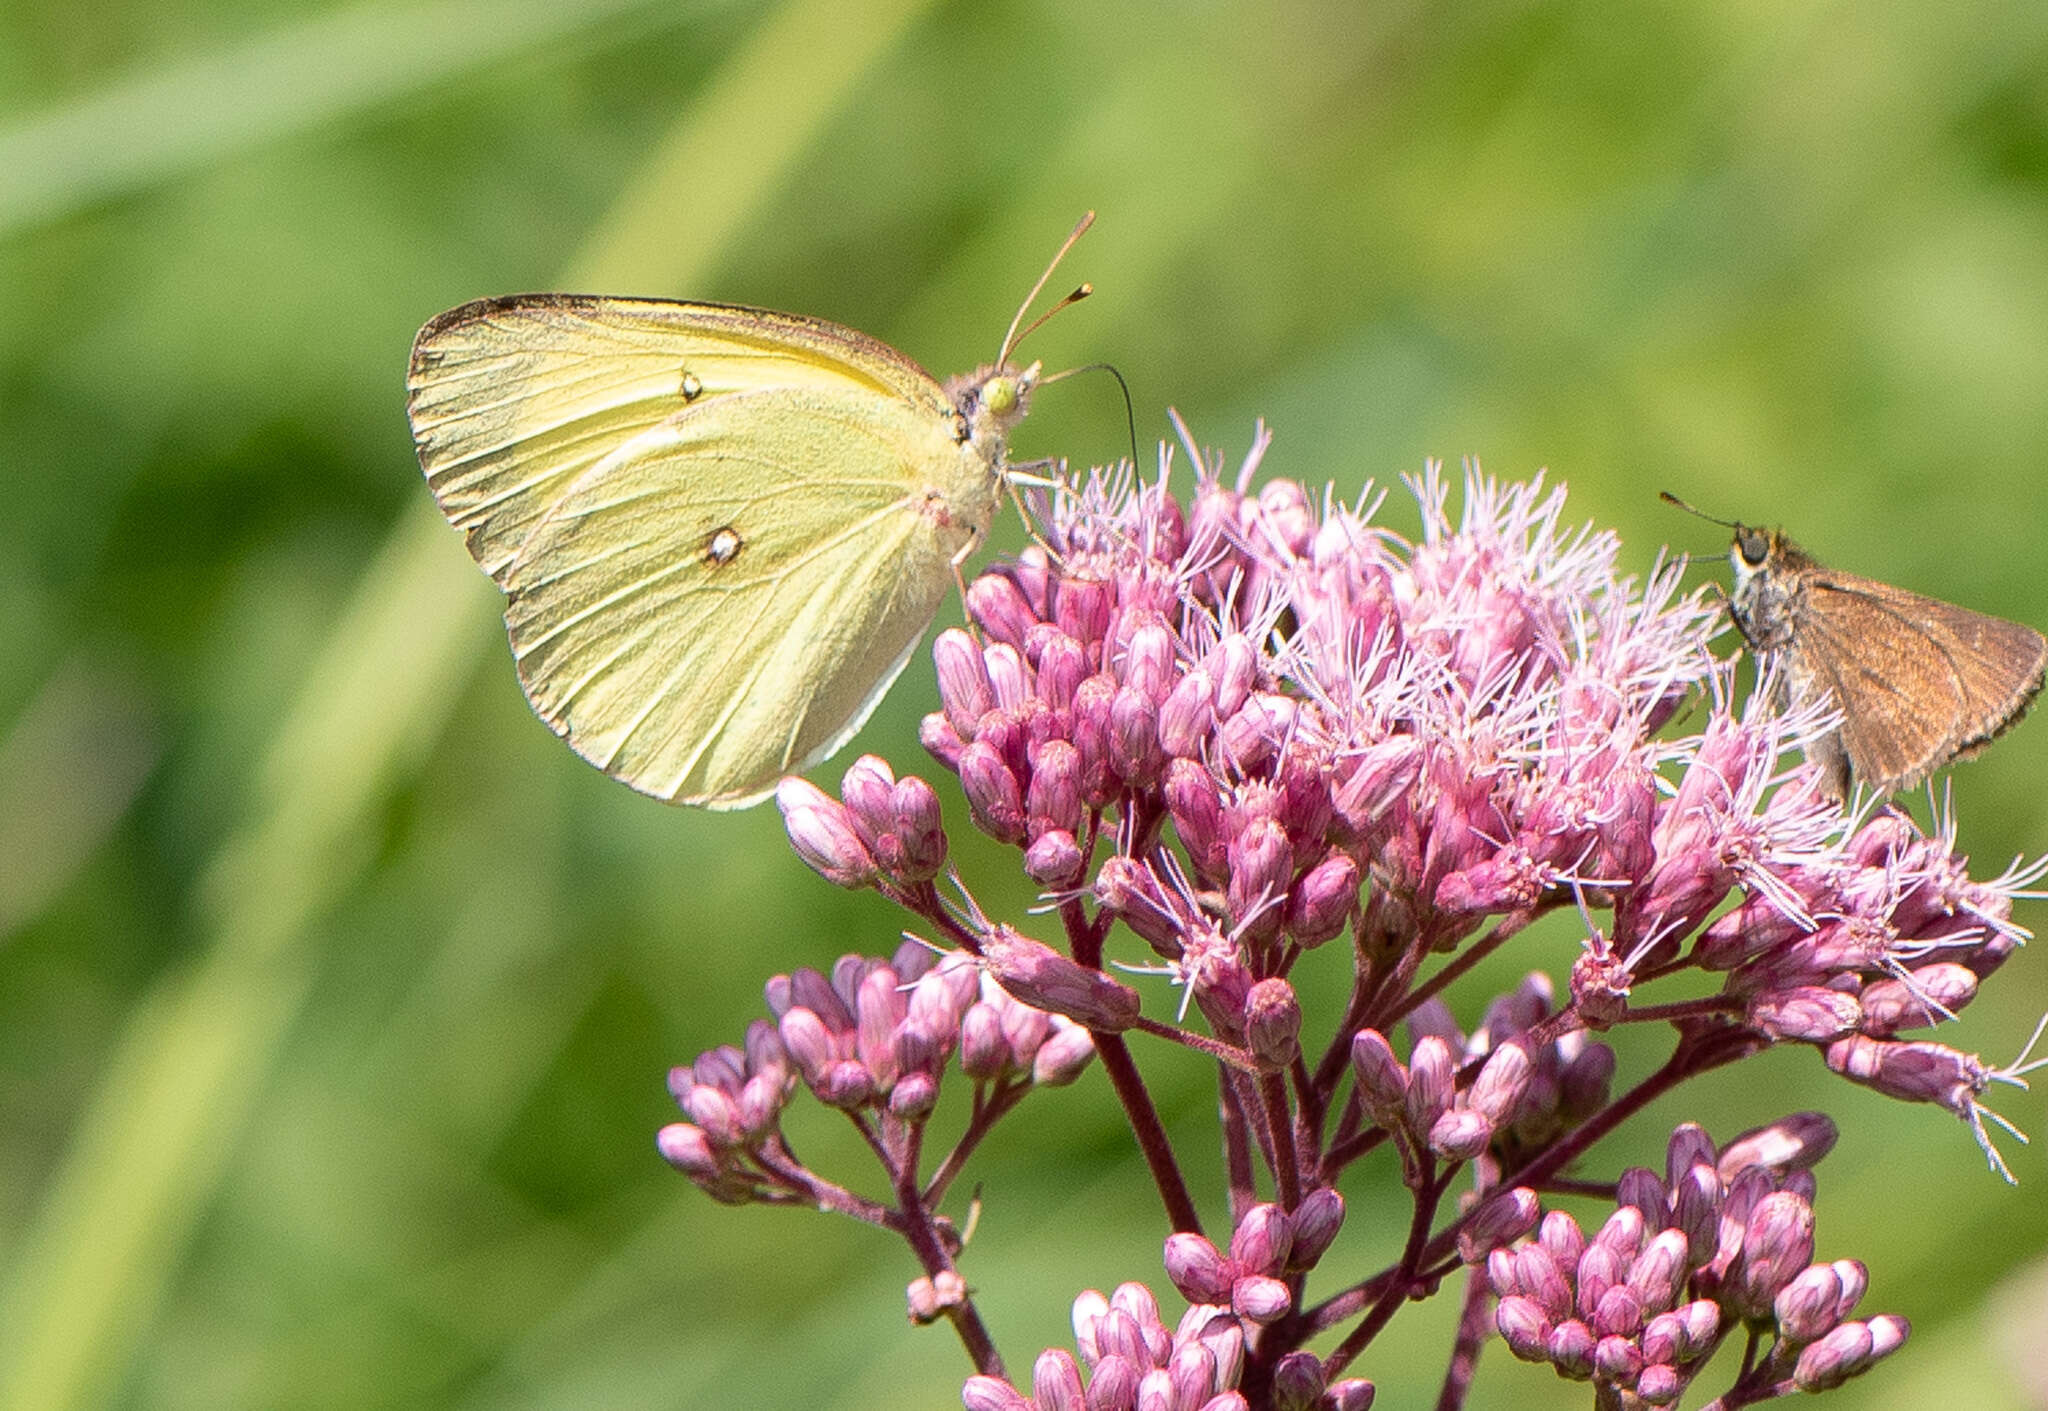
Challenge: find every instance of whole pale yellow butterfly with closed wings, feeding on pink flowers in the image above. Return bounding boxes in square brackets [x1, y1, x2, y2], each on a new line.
[408, 213, 1094, 809]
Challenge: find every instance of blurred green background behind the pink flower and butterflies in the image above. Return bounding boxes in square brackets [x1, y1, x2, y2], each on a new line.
[0, 0, 2048, 1411]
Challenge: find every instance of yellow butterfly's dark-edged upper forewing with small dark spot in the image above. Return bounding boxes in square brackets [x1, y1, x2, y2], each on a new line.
[408, 295, 950, 582]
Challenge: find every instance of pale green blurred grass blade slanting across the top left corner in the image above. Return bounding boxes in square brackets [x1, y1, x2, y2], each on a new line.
[0, 0, 704, 238]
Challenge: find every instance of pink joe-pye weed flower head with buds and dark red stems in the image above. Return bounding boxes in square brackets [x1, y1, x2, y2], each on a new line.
[659, 430, 2040, 1411]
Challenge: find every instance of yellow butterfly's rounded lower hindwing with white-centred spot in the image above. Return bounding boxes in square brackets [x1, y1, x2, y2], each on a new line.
[504, 387, 974, 805]
